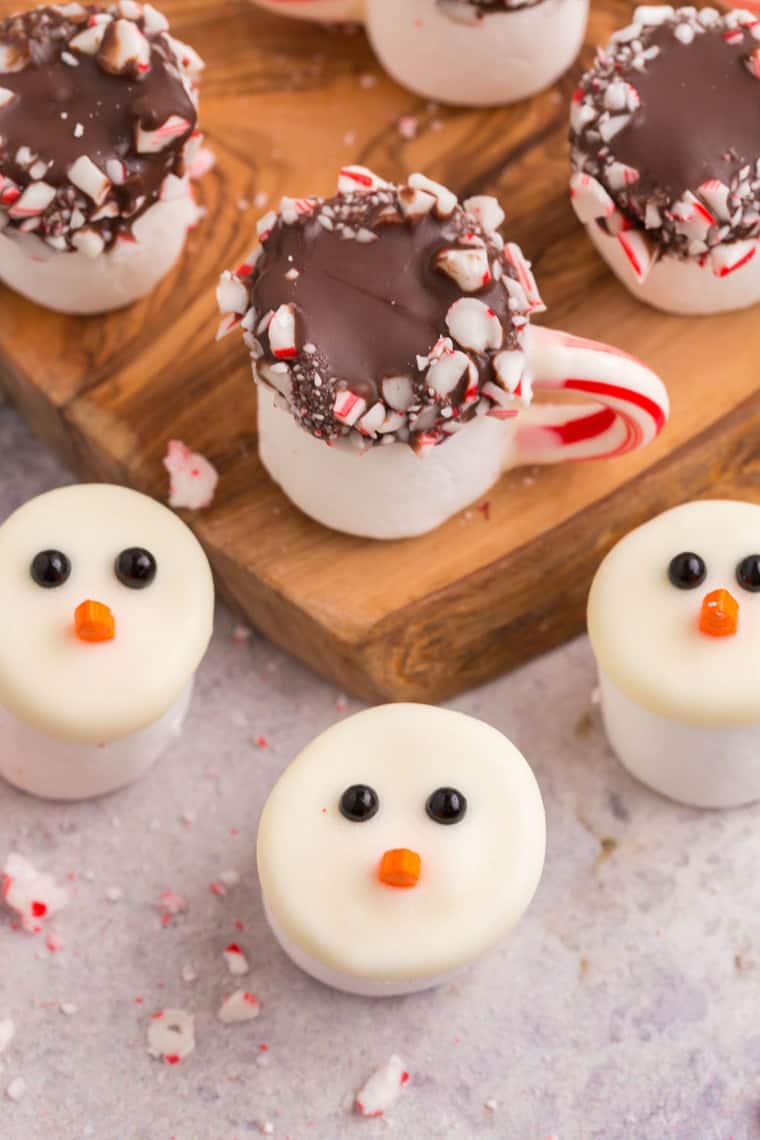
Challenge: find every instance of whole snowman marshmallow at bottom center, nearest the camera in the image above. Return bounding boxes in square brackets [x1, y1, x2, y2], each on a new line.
[258, 705, 546, 996]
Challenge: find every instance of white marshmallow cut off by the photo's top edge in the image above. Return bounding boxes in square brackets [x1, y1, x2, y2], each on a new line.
[367, 0, 588, 106]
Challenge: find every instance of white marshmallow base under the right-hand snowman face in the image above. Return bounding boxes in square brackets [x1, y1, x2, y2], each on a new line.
[599, 669, 760, 807]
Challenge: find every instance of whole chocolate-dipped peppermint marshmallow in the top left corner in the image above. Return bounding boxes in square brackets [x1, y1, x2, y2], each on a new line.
[0, 0, 203, 314]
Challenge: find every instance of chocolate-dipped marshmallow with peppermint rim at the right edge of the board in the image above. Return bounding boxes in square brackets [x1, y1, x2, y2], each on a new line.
[570, 7, 760, 314]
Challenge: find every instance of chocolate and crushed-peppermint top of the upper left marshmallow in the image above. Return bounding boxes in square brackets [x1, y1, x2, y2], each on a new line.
[0, 0, 203, 255]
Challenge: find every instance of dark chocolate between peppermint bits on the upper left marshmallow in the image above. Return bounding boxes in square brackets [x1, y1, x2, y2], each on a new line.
[0, 6, 197, 245]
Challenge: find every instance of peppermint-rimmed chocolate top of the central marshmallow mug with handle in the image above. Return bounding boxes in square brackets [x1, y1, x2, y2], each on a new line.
[219, 166, 544, 450]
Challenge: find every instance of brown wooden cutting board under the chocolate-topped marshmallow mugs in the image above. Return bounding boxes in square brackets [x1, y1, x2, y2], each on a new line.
[0, 0, 760, 700]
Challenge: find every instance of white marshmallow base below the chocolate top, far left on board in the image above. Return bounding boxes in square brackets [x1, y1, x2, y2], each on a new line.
[0, 186, 197, 316]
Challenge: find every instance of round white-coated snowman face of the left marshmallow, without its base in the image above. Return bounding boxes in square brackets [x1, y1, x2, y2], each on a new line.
[0, 485, 213, 747]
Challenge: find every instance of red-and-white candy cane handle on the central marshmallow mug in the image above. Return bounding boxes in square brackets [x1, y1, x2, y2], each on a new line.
[513, 326, 670, 464]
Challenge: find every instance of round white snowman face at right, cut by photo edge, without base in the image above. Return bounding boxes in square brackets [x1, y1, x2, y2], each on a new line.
[589, 500, 760, 724]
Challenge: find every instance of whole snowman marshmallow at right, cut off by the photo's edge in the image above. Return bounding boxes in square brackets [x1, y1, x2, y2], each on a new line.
[588, 500, 760, 807]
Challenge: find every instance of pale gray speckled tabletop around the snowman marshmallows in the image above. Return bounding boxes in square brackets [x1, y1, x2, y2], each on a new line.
[0, 406, 760, 1140]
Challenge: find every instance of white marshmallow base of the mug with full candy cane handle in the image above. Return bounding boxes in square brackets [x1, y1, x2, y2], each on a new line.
[258, 384, 517, 539]
